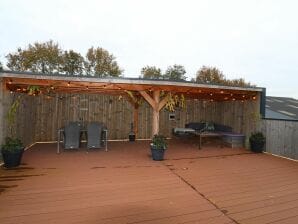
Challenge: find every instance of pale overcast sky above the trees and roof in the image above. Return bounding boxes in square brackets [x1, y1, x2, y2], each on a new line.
[0, 0, 298, 99]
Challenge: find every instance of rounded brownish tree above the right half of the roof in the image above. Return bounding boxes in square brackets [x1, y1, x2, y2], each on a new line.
[196, 66, 225, 84]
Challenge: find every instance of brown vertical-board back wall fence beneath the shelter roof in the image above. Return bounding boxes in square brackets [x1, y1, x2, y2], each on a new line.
[10, 94, 259, 142]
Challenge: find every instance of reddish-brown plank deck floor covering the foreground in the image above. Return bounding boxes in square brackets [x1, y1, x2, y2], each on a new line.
[0, 140, 298, 224]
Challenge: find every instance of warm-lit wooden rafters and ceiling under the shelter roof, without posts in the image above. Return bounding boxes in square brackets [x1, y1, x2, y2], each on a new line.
[4, 74, 260, 100]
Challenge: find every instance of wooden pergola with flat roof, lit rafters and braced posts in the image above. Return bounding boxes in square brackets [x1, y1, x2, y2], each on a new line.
[0, 71, 262, 135]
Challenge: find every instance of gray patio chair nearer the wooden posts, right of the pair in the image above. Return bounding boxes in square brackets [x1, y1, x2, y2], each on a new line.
[87, 122, 107, 149]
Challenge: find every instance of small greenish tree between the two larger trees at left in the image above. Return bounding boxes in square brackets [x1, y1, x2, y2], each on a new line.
[60, 50, 85, 75]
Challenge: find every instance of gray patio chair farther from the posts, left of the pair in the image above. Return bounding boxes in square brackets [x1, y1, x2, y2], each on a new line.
[64, 122, 81, 149]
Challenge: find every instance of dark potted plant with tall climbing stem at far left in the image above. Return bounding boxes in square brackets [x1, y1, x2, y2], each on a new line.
[1, 95, 24, 168]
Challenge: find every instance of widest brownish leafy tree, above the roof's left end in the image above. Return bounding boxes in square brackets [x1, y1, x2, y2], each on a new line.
[6, 40, 62, 73]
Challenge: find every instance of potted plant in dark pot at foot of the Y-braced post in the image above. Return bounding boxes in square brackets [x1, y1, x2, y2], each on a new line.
[150, 135, 167, 161]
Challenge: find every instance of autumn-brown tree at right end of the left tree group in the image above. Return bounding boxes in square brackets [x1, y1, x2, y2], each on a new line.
[85, 47, 122, 77]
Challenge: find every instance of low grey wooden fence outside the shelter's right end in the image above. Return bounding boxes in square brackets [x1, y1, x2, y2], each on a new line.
[261, 119, 298, 160]
